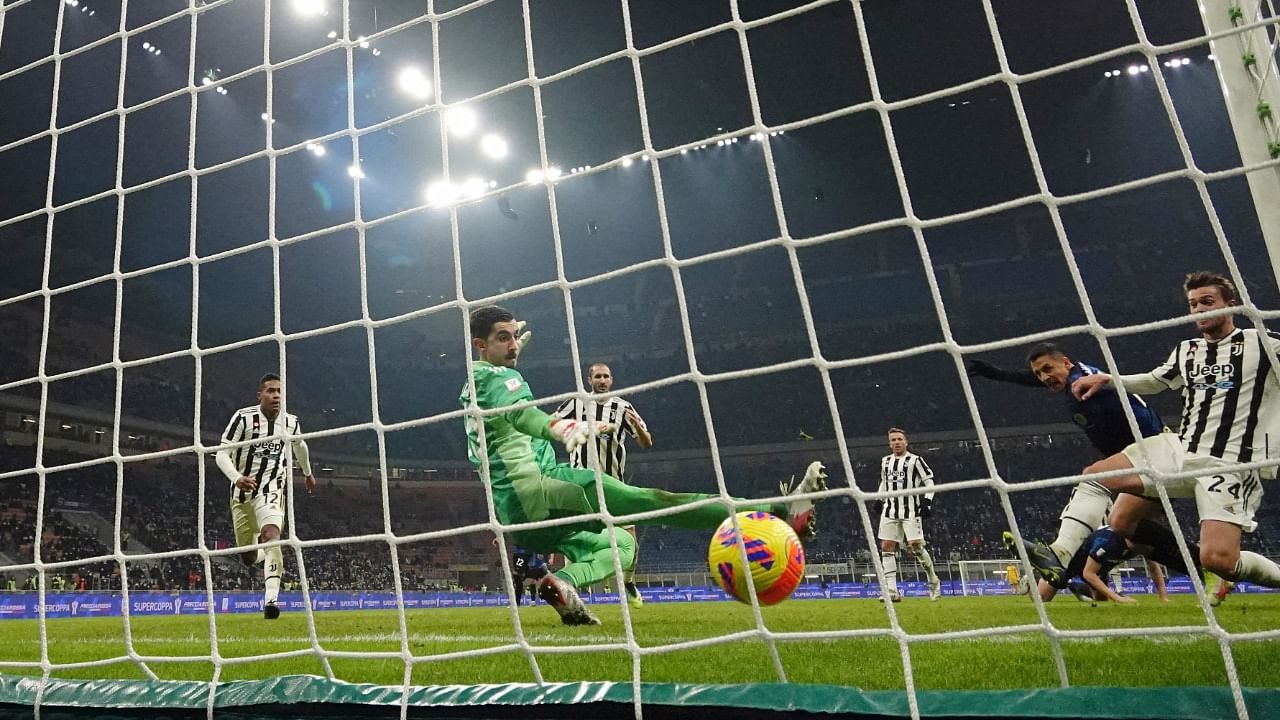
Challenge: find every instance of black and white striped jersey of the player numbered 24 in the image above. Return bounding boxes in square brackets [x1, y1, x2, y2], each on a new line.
[1151, 328, 1280, 462]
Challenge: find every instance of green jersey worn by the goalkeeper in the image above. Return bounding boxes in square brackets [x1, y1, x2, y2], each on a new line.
[458, 360, 556, 512]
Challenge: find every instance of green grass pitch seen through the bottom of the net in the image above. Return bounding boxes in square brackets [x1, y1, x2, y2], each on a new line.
[0, 594, 1280, 689]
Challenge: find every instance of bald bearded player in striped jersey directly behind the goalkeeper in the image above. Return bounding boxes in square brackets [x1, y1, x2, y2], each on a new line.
[553, 363, 653, 609]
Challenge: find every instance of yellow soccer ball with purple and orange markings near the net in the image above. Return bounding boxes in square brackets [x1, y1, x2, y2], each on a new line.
[707, 511, 804, 605]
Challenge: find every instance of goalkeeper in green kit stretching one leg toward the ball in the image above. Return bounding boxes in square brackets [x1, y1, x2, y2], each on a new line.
[458, 305, 827, 625]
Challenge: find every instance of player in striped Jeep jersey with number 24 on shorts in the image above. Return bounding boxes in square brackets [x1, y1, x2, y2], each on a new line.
[1071, 273, 1280, 597]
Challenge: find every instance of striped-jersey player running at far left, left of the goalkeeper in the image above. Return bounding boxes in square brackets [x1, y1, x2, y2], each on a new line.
[215, 373, 316, 620]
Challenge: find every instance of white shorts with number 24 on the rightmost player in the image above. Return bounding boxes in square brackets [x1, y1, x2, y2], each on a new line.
[1123, 433, 1262, 533]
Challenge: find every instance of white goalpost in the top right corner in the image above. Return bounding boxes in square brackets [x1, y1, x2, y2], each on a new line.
[1199, 0, 1280, 289]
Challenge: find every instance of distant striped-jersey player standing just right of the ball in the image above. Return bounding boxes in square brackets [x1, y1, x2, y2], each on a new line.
[877, 428, 942, 602]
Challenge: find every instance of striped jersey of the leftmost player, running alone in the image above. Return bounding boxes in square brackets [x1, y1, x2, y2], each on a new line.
[218, 405, 311, 501]
